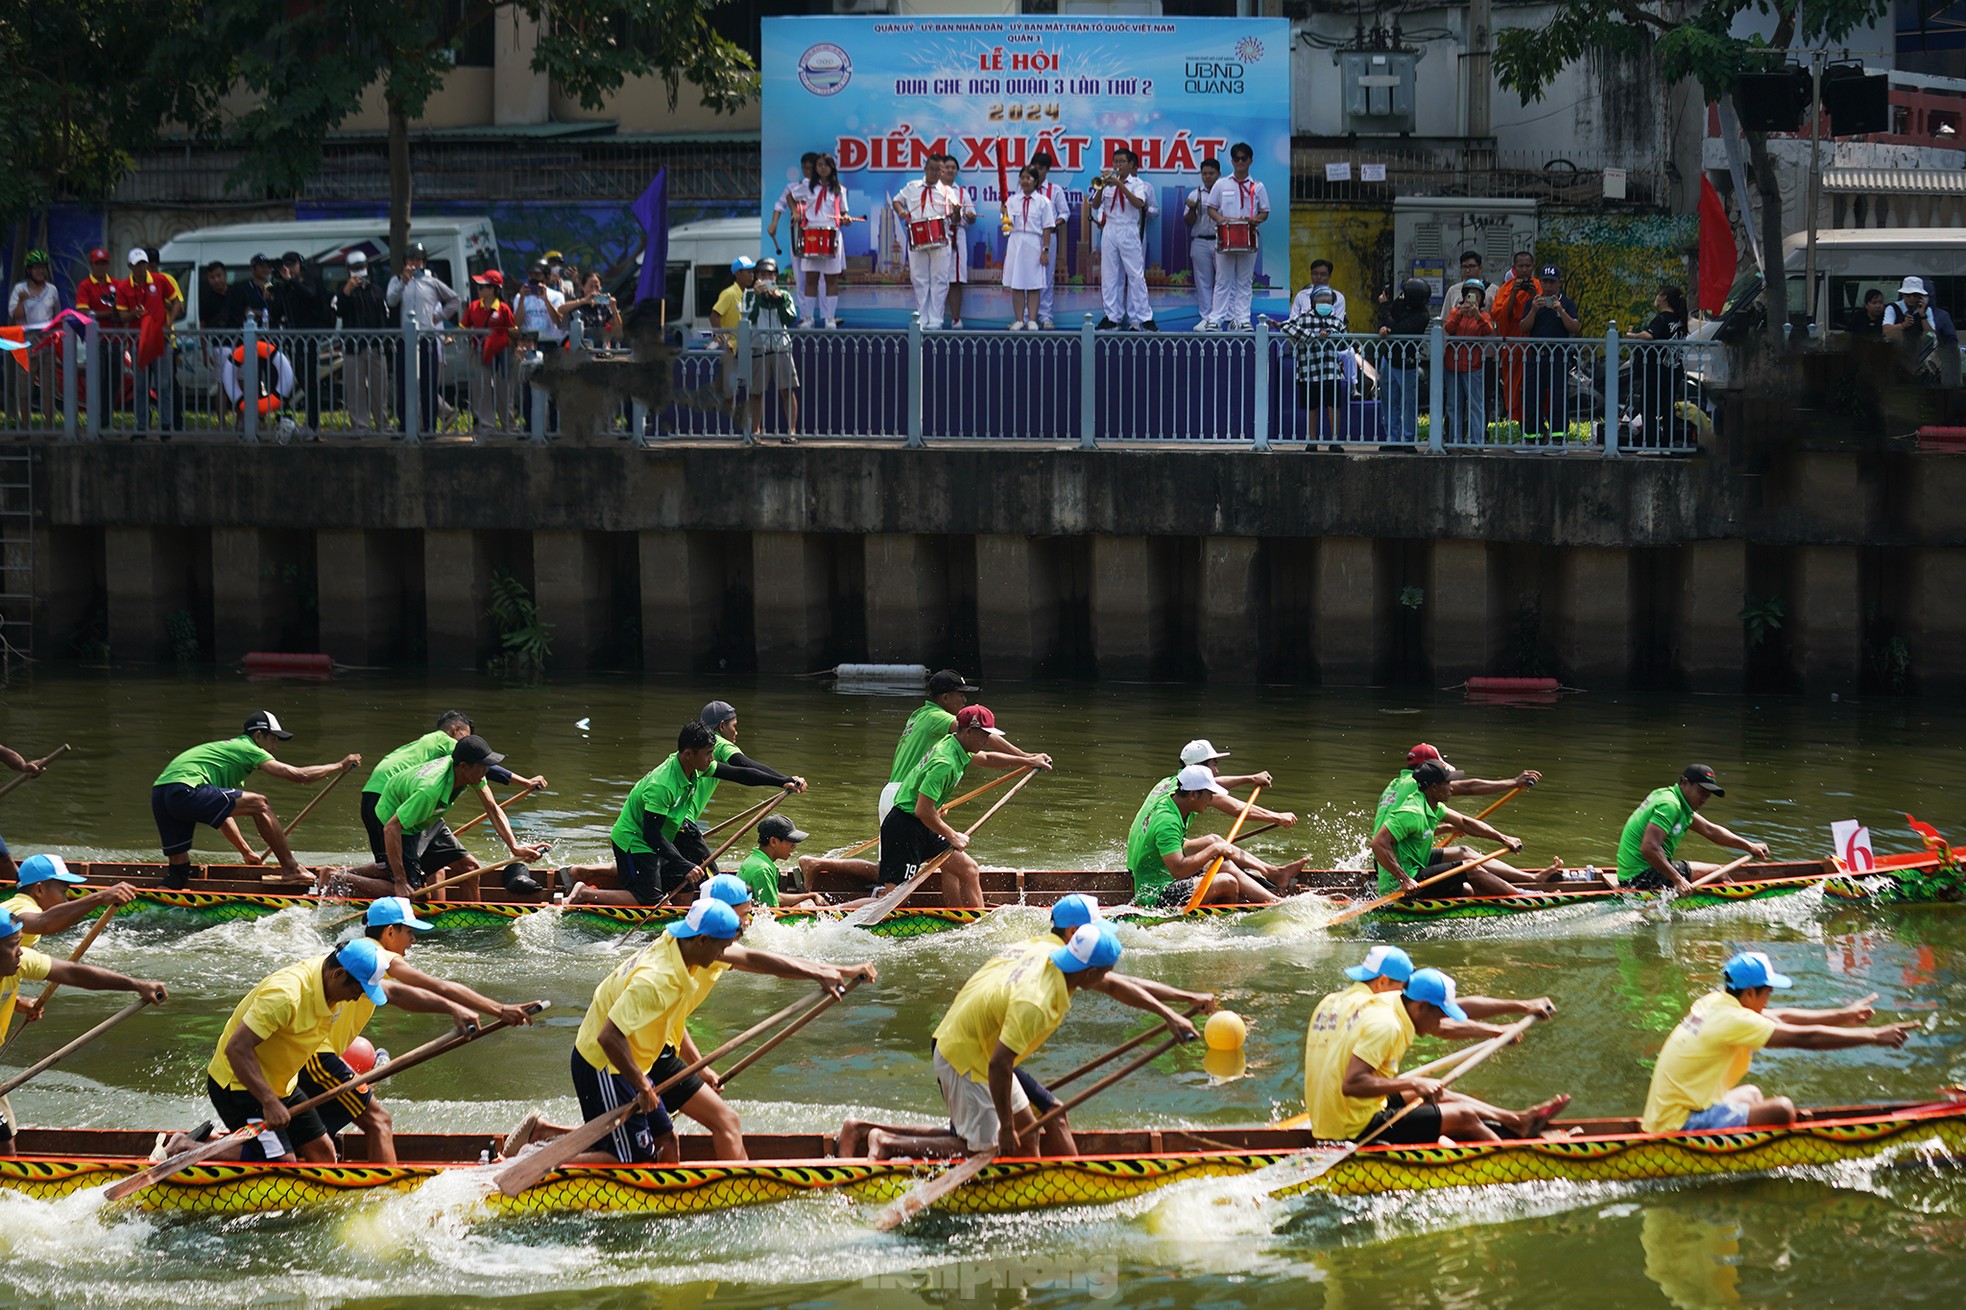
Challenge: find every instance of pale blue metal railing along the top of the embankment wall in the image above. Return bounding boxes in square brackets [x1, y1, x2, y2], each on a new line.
[0, 317, 1712, 454]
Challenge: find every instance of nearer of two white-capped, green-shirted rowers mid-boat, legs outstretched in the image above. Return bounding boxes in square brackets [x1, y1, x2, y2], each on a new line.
[1127, 763, 1303, 909]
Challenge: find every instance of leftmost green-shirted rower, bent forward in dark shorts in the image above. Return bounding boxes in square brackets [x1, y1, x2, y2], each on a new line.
[149, 710, 362, 891]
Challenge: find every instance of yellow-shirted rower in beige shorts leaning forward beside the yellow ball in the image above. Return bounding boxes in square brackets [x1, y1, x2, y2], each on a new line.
[865, 923, 1213, 1161]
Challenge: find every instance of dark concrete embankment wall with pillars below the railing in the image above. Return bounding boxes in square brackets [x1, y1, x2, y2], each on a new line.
[35, 433, 1966, 692]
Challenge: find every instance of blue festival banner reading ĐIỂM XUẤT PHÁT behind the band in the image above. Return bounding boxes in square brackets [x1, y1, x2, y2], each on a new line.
[761, 16, 1292, 325]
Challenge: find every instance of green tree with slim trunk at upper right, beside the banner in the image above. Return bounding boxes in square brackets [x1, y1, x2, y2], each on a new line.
[1494, 0, 1895, 340]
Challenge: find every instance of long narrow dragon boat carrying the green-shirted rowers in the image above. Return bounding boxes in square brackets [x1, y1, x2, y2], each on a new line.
[42, 852, 1962, 936]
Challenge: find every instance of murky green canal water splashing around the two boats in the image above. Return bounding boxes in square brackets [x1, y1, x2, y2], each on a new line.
[0, 673, 1966, 1310]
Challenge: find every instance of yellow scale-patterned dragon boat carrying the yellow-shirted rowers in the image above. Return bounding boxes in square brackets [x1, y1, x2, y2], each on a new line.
[0, 1100, 1966, 1216]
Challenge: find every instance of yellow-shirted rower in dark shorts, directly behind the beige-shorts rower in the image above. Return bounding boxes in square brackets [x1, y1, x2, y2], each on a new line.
[503, 896, 875, 1164]
